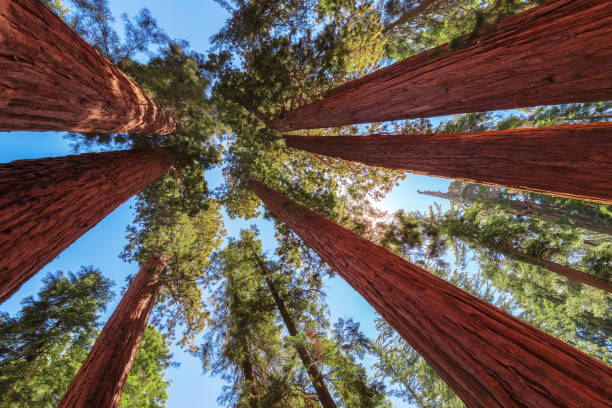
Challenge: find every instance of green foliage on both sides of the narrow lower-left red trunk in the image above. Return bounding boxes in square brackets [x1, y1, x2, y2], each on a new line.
[0, 267, 171, 408]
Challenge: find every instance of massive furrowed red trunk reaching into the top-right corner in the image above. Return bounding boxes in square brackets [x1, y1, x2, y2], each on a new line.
[272, 0, 612, 132]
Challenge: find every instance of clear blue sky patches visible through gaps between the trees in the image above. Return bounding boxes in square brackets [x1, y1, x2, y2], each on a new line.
[0, 0, 449, 408]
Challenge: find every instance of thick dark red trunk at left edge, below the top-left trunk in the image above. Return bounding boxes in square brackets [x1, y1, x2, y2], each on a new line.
[0, 149, 172, 303]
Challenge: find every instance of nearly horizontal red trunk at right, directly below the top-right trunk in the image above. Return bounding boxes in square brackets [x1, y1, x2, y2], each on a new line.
[284, 121, 612, 204]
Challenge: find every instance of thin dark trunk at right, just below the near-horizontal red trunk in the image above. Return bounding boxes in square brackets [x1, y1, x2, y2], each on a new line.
[418, 191, 612, 234]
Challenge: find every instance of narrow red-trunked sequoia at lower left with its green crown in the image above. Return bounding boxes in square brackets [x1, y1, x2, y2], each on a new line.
[59, 176, 223, 407]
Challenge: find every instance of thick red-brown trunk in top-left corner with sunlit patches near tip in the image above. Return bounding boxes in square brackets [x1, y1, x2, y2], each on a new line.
[0, 0, 177, 134]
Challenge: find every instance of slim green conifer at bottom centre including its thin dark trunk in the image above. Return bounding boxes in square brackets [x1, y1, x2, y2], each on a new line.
[205, 230, 384, 407]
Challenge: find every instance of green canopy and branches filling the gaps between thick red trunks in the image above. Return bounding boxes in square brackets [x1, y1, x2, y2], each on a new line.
[14, 0, 612, 408]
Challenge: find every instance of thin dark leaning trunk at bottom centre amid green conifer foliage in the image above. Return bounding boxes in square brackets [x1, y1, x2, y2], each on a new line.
[253, 252, 336, 408]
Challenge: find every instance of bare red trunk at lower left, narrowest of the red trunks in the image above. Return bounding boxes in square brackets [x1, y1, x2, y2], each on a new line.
[58, 257, 167, 408]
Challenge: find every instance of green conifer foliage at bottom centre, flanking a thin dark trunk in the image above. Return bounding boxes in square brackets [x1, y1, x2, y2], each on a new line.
[202, 230, 386, 407]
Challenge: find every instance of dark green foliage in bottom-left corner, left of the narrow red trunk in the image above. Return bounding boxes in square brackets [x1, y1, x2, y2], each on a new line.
[0, 268, 112, 407]
